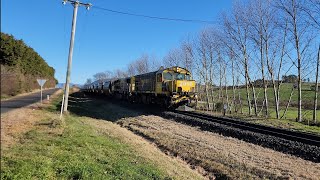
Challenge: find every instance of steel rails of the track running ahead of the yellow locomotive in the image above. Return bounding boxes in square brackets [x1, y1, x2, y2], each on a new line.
[174, 110, 320, 147]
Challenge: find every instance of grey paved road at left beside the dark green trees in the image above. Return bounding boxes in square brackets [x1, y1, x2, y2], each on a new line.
[1, 89, 58, 114]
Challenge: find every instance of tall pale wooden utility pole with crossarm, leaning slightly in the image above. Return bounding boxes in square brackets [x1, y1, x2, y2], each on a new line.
[62, 0, 92, 112]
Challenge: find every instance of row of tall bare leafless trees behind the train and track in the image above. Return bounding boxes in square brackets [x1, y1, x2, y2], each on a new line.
[87, 0, 320, 123]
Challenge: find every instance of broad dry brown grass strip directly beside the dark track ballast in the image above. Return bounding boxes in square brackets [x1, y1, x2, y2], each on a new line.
[119, 115, 320, 179]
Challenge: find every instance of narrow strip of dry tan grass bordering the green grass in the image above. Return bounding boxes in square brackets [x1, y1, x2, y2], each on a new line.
[83, 118, 203, 179]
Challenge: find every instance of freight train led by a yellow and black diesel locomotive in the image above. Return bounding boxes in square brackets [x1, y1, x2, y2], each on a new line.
[83, 66, 197, 108]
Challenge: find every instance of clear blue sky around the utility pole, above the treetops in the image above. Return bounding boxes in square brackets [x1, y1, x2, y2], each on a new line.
[1, 0, 232, 84]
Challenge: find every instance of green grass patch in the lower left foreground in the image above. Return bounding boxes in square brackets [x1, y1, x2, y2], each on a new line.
[1, 115, 167, 179]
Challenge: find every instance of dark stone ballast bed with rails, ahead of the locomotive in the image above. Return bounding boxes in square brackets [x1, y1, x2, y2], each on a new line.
[163, 111, 320, 163]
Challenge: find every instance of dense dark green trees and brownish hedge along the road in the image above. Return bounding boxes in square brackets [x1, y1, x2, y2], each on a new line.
[0, 32, 57, 95]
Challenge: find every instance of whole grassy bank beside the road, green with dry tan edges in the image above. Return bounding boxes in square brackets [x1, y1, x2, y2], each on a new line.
[1, 92, 199, 179]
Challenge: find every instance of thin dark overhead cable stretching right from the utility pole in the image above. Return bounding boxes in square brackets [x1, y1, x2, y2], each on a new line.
[92, 6, 218, 24]
